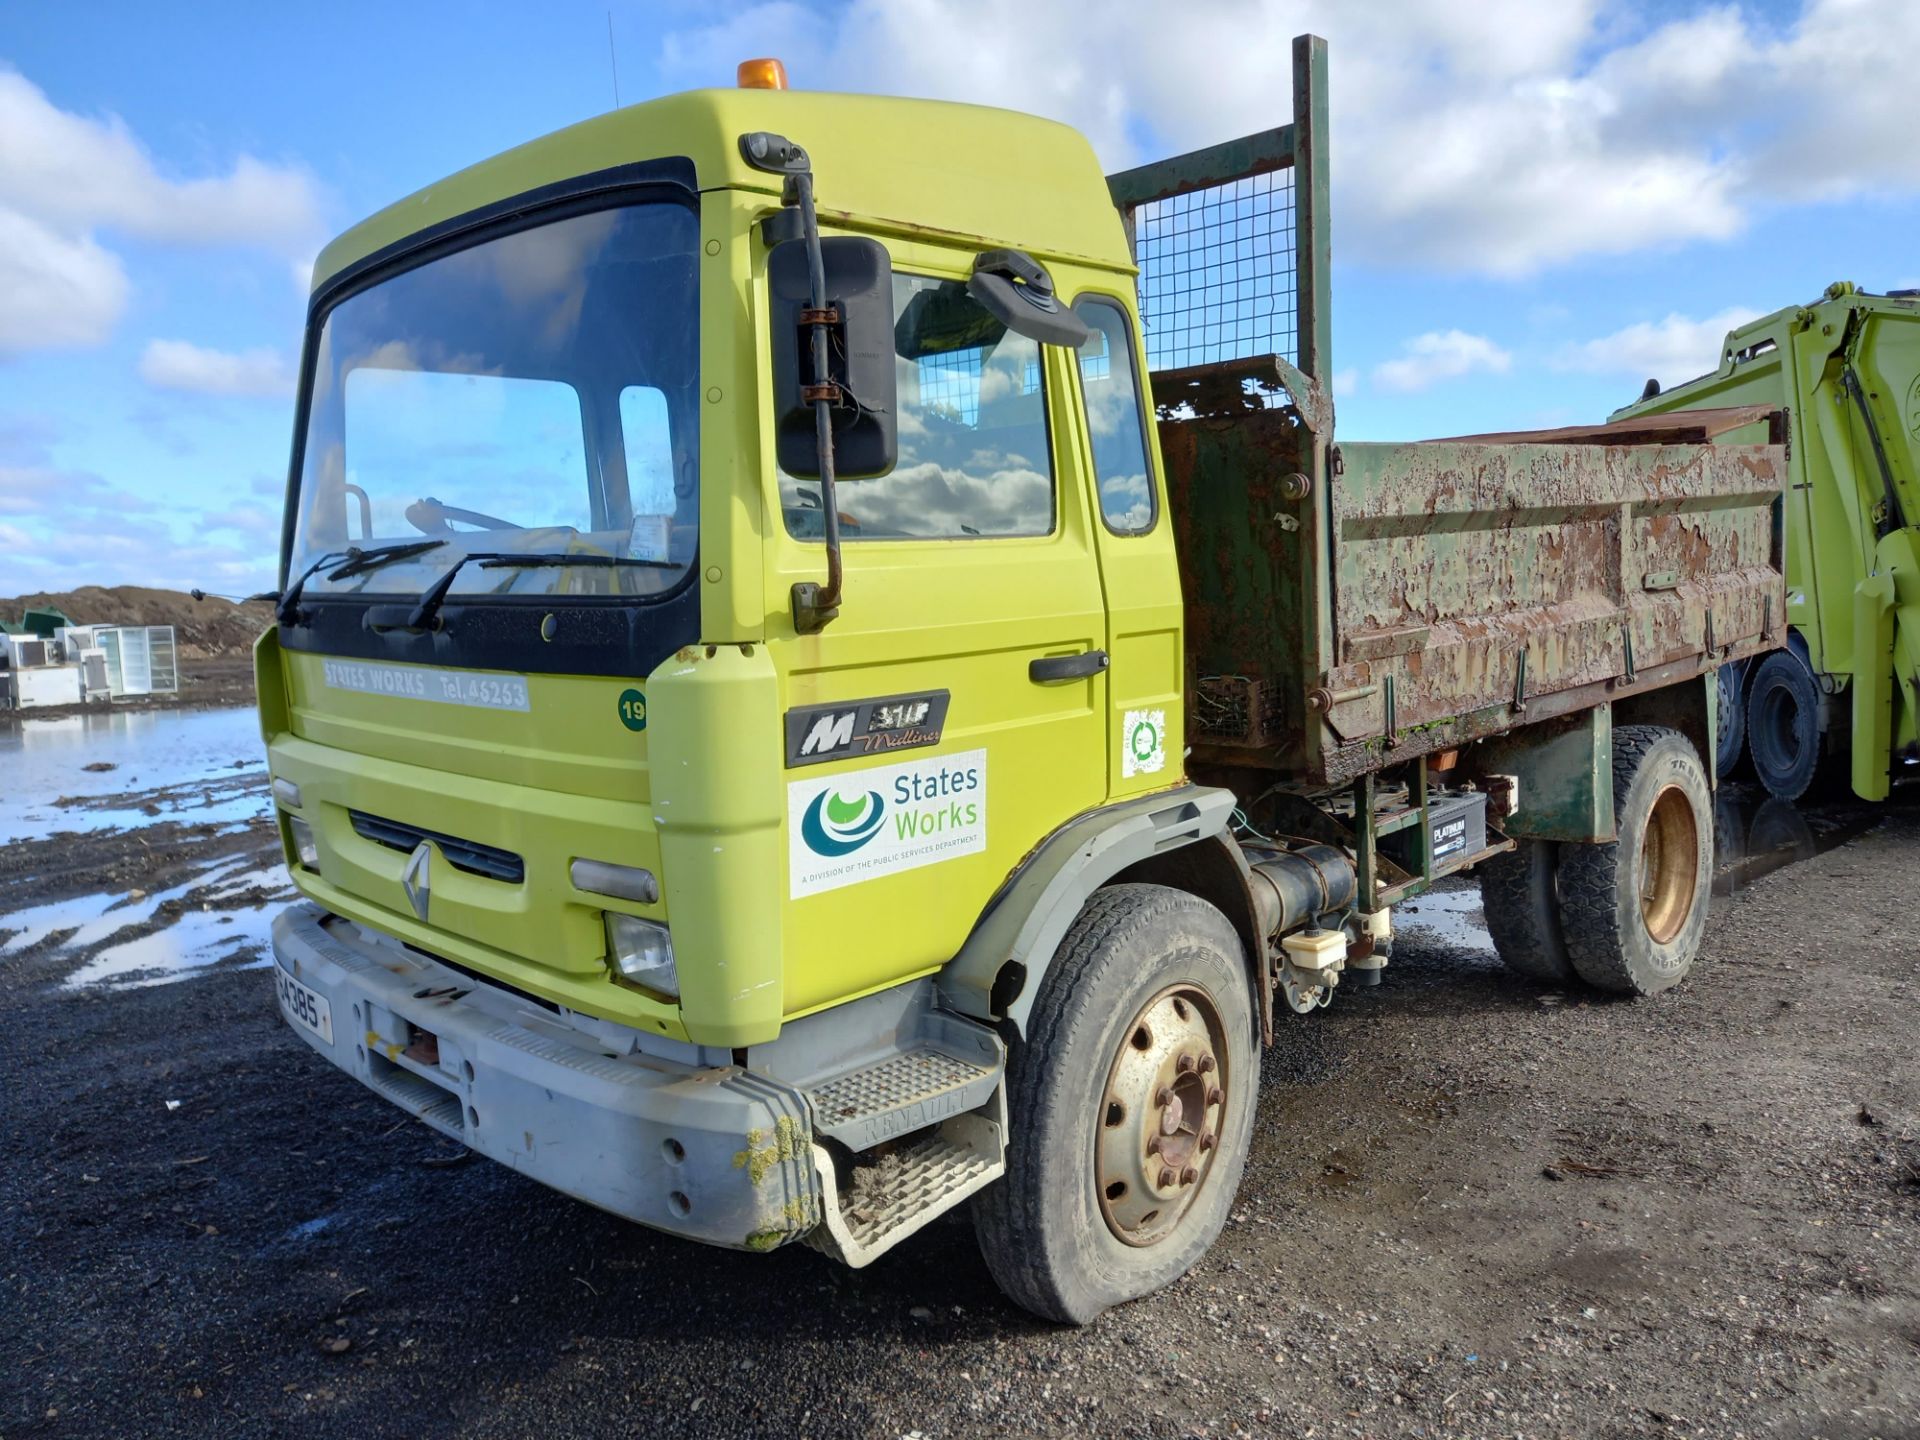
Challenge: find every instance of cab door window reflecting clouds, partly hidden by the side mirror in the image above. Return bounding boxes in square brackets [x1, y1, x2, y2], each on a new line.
[780, 271, 1054, 541]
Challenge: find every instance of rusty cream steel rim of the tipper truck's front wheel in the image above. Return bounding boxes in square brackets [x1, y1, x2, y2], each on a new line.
[1094, 985, 1229, 1246]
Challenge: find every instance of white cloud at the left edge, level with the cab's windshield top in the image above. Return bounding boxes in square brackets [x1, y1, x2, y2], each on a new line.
[0, 69, 323, 355]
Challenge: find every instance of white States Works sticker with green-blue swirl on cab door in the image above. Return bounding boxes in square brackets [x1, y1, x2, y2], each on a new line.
[787, 751, 987, 899]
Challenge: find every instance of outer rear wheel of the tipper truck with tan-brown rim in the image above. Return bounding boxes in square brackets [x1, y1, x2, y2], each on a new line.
[1559, 726, 1713, 995]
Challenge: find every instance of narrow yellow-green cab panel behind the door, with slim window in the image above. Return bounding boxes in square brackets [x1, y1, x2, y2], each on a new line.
[1071, 292, 1187, 799]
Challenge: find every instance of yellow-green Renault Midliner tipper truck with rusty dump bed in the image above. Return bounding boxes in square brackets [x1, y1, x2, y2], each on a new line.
[257, 38, 1786, 1321]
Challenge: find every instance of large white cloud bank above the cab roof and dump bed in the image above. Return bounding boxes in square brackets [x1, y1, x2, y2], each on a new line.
[660, 0, 1920, 275]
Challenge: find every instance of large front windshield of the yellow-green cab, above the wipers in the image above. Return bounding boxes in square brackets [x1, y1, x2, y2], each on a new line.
[288, 202, 699, 597]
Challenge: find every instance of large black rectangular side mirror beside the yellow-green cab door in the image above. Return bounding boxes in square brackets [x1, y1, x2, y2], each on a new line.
[766, 236, 900, 480]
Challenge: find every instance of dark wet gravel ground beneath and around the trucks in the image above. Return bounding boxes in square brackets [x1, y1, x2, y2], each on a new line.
[0, 806, 1920, 1440]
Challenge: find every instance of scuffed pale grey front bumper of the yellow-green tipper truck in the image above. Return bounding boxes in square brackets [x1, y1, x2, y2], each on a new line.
[273, 904, 820, 1250]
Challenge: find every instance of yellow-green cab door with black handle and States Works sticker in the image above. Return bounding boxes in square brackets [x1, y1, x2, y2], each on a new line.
[768, 246, 1110, 1016]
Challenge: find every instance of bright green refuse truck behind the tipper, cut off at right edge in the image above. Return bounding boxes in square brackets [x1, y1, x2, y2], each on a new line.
[1613, 280, 1920, 801]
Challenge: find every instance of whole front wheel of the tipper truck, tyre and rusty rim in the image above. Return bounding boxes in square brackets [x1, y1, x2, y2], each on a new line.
[973, 885, 1260, 1325]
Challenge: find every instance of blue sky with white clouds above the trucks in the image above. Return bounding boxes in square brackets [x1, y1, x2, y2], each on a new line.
[0, 0, 1920, 595]
